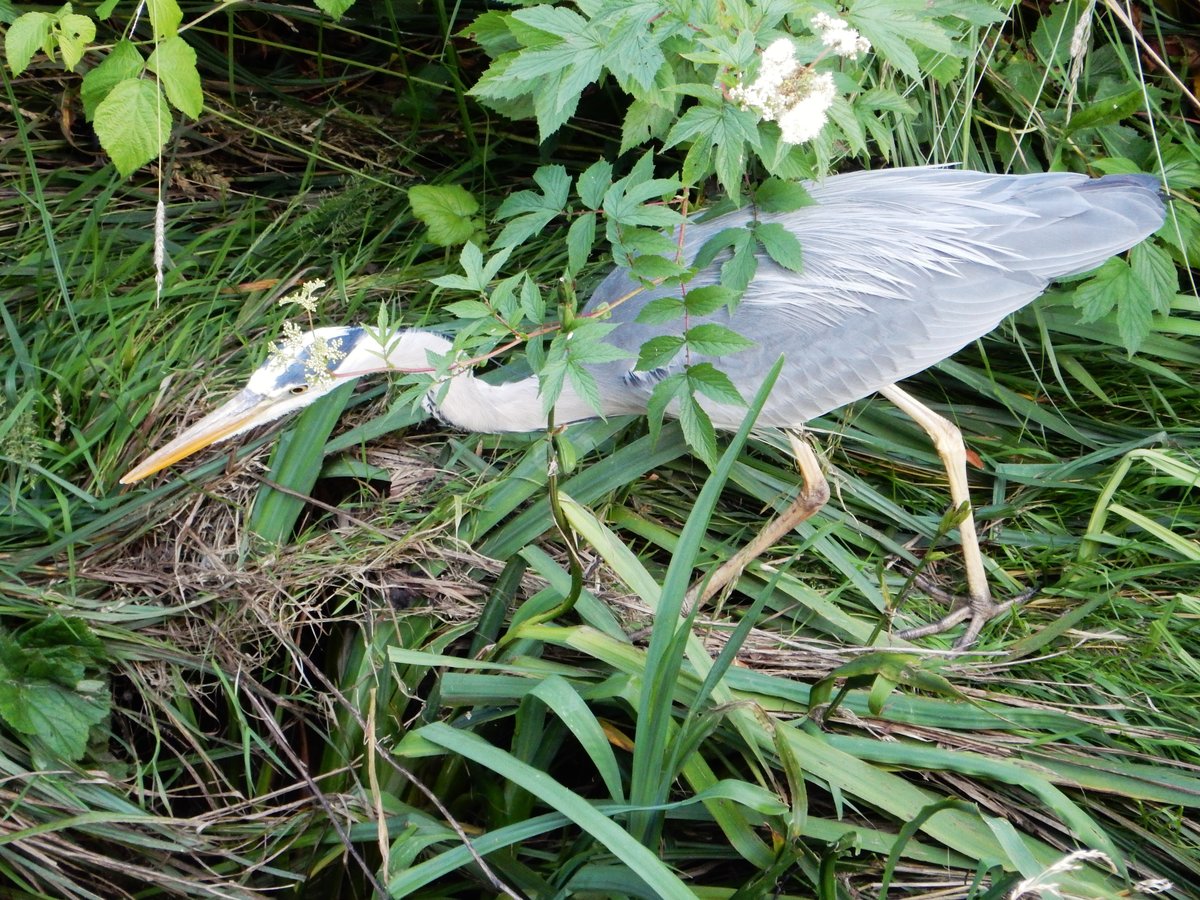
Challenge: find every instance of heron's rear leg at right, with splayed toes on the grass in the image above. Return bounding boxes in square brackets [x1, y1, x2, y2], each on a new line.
[880, 384, 1027, 648]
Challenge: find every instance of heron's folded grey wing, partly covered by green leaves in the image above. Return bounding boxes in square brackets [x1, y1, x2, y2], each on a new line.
[589, 168, 1164, 427]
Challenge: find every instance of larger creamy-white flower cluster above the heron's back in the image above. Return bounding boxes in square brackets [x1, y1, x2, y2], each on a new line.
[730, 37, 835, 144]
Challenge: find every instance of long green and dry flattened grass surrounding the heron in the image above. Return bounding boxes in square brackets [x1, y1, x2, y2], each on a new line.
[0, 5, 1200, 898]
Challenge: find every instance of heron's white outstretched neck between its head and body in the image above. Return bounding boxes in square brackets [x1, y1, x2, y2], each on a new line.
[364, 330, 598, 433]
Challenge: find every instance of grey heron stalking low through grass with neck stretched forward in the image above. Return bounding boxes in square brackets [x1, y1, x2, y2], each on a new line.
[121, 167, 1165, 646]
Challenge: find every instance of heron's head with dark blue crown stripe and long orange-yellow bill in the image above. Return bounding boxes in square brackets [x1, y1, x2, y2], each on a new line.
[121, 328, 374, 485]
